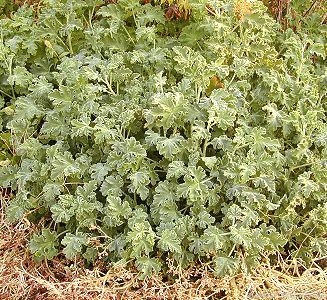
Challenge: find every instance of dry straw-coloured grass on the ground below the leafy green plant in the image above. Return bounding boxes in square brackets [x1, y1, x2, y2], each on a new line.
[0, 195, 327, 300]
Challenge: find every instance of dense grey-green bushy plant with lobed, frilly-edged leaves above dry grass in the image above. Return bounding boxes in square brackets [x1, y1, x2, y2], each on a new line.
[0, 0, 327, 278]
